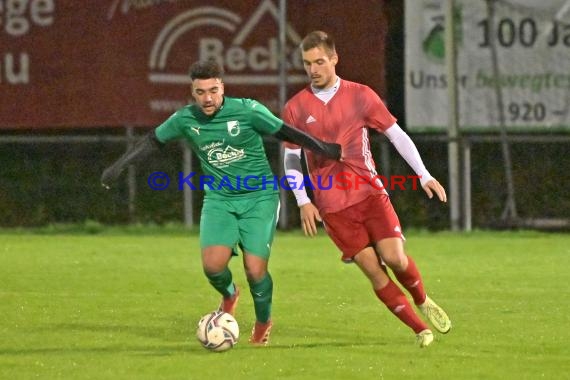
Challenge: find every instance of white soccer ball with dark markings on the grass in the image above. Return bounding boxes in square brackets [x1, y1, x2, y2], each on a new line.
[196, 310, 239, 352]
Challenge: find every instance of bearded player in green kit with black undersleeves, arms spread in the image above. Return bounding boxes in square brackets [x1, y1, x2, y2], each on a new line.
[101, 61, 341, 345]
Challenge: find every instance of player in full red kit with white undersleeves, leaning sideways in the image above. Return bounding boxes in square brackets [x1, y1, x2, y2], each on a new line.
[282, 31, 451, 347]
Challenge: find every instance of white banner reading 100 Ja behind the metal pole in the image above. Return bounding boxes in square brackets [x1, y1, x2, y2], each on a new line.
[405, 0, 570, 132]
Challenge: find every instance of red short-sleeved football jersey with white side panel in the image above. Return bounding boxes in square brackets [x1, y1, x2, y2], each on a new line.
[282, 80, 396, 215]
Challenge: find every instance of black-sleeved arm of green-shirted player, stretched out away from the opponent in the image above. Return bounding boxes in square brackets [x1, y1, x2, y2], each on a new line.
[101, 131, 163, 189]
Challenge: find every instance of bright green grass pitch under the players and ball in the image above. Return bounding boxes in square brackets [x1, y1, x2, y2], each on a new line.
[0, 228, 570, 380]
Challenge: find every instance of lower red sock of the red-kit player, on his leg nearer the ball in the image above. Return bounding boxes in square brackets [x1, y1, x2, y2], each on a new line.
[374, 280, 428, 334]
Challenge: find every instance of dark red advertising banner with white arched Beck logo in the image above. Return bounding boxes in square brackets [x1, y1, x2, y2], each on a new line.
[0, 0, 386, 129]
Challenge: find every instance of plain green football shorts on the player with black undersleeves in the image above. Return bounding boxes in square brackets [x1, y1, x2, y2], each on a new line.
[200, 194, 279, 260]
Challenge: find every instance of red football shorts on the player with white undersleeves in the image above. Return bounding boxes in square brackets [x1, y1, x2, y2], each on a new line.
[323, 194, 404, 262]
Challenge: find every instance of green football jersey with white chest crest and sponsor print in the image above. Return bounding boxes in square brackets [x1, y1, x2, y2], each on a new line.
[155, 96, 283, 198]
